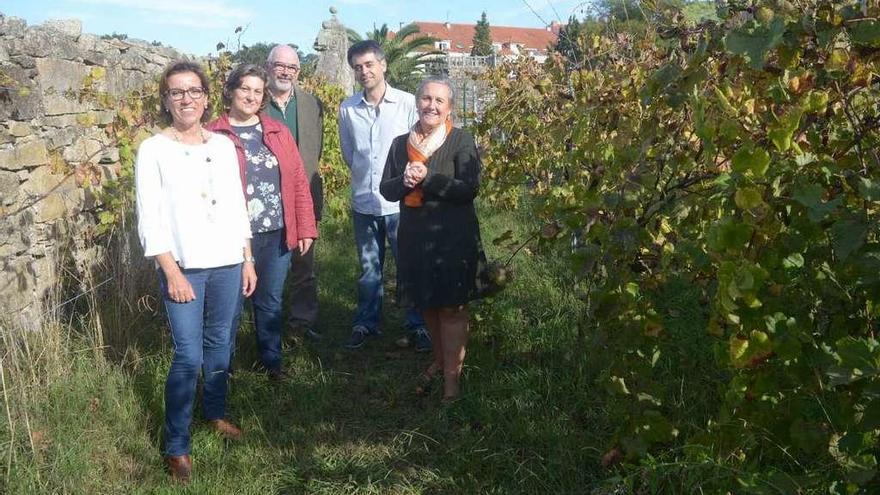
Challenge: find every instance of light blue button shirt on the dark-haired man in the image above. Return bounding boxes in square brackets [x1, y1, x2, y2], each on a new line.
[339, 86, 418, 215]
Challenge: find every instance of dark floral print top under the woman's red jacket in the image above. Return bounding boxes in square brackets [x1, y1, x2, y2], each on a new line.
[232, 122, 284, 234]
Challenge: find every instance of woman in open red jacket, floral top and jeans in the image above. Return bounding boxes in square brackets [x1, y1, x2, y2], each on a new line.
[208, 64, 318, 380]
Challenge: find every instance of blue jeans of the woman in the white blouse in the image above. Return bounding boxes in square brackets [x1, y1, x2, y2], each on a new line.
[159, 264, 241, 456]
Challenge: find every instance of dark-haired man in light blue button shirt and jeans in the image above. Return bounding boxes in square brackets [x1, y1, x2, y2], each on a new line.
[339, 40, 431, 352]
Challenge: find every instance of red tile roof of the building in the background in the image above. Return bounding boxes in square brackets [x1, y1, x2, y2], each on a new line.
[404, 21, 561, 53]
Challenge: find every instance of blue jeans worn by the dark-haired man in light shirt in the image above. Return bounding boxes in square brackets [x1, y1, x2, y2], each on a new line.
[351, 211, 425, 333]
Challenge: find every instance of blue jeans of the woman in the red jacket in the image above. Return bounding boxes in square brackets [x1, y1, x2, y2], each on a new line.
[230, 229, 290, 370]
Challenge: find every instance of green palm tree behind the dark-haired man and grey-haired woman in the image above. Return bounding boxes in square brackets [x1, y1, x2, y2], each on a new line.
[348, 24, 442, 93]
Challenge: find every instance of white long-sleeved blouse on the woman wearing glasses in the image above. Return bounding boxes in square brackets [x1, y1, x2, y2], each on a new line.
[135, 134, 251, 268]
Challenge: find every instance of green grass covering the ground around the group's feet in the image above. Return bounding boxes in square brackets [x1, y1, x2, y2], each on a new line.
[0, 203, 696, 495]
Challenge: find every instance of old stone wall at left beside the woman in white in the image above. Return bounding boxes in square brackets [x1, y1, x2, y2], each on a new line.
[0, 13, 181, 320]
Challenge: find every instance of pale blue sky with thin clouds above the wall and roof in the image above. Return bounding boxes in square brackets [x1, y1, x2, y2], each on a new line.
[0, 0, 590, 55]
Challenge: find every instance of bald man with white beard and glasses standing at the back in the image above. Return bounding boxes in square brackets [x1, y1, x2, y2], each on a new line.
[264, 45, 324, 340]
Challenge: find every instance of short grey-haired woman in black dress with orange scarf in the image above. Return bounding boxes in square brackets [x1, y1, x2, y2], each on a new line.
[380, 77, 485, 401]
